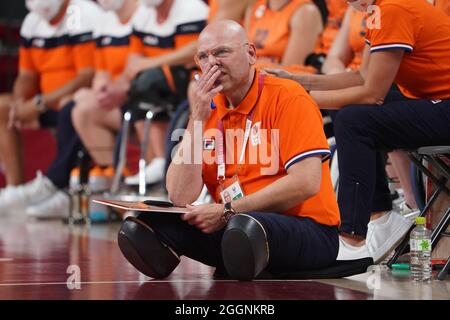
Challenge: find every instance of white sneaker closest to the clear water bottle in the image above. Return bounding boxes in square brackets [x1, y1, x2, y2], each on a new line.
[366, 211, 413, 263]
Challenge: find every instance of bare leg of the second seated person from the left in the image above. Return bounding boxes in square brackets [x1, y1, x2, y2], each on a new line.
[72, 89, 121, 166]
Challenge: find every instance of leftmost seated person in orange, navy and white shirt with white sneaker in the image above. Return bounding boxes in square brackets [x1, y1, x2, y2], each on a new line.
[0, 0, 100, 213]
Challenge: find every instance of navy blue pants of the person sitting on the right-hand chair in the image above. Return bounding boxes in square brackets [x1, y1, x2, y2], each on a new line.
[334, 91, 450, 237]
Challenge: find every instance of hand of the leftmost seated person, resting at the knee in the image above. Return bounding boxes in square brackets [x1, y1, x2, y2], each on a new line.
[8, 99, 39, 129]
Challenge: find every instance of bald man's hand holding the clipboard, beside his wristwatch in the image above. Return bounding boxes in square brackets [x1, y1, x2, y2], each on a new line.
[181, 203, 225, 233]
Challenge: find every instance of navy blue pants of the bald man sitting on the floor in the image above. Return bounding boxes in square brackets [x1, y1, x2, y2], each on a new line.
[138, 212, 339, 272]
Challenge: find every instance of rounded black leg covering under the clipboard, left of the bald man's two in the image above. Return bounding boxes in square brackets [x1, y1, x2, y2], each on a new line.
[117, 217, 180, 279]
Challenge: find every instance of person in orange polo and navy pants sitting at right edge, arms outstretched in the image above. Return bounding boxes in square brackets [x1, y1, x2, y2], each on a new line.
[272, 0, 450, 263]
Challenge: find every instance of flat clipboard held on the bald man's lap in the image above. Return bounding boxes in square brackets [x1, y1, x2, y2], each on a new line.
[92, 200, 187, 214]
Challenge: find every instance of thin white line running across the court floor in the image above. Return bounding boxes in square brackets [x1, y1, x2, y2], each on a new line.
[0, 279, 314, 287]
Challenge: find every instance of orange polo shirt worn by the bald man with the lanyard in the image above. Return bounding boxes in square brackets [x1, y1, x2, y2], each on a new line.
[202, 71, 340, 226]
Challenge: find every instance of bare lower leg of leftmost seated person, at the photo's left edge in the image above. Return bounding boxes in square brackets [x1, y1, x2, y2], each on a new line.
[0, 94, 24, 186]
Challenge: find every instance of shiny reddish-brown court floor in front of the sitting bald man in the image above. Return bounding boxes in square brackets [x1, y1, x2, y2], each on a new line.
[0, 215, 450, 300]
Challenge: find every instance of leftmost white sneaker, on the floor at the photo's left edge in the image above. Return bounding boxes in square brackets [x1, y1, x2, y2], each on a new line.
[0, 171, 57, 214]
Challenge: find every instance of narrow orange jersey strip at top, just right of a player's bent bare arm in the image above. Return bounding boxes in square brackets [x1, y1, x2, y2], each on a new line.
[315, 0, 348, 54]
